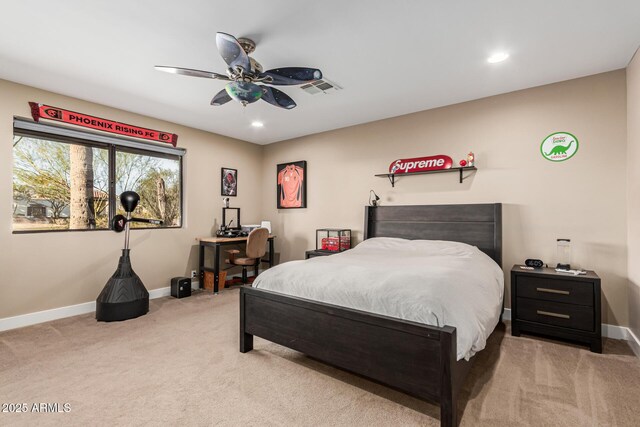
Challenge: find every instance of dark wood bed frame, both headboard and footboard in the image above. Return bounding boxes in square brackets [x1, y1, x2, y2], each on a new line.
[240, 204, 502, 426]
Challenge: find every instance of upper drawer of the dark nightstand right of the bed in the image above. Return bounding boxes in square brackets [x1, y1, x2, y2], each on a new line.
[517, 276, 594, 306]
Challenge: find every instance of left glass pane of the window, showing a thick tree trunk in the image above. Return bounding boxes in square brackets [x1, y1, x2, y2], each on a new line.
[13, 135, 109, 231]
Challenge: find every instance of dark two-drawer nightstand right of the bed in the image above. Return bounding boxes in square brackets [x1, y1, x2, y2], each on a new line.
[511, 265, 602, 353]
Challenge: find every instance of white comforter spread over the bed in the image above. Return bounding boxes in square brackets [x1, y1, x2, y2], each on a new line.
[253, 238, 504, 360]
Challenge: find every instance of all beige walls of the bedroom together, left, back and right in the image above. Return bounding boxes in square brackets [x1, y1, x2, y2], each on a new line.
[0, 72, 640, 333]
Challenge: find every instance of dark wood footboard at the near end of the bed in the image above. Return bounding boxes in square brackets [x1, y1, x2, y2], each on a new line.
[240, 287, 469, 426]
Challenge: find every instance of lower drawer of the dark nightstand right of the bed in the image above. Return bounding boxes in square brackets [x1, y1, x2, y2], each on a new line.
[517, 298, 594, 331]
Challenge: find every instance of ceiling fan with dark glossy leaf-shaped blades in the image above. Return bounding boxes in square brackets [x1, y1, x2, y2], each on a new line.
[155, 33, 322, 110]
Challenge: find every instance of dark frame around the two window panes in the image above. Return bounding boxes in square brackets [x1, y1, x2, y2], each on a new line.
[11, 117, 186, 234]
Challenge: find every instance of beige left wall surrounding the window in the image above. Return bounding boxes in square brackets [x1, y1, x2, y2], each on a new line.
[0, 80, 262, 318]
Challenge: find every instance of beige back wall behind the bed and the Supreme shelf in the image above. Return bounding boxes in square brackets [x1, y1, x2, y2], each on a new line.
[262, 70, 628, 325]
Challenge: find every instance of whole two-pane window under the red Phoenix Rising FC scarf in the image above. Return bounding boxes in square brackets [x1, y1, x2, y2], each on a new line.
[13, 118, 184, 233]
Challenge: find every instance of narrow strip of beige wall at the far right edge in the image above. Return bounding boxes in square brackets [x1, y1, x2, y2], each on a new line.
[627, 52, 640, 337]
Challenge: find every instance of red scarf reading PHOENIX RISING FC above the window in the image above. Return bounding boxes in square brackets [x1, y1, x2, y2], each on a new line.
[29, 102, 178, 147]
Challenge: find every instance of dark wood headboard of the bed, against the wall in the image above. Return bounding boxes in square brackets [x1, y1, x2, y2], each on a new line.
[364, 203, 502, 267]
